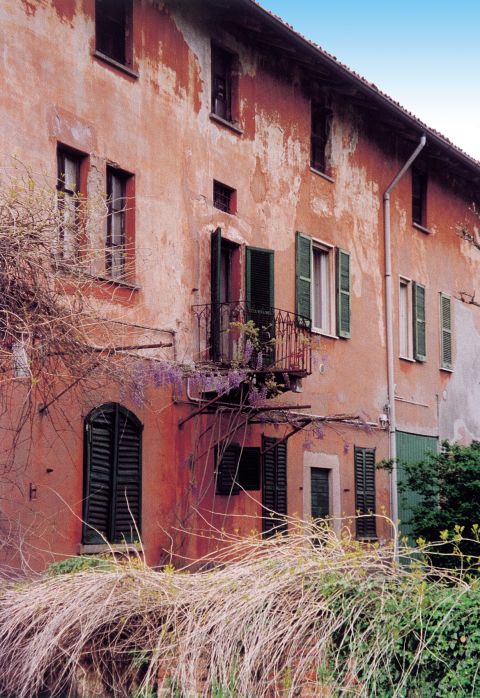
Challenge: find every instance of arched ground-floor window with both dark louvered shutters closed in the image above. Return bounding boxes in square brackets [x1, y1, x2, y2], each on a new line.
[83, 403, 142, 544]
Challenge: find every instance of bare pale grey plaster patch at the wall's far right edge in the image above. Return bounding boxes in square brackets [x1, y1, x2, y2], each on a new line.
[439, 300, 480, 442]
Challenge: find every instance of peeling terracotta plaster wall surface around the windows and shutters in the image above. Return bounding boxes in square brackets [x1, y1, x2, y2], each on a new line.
[0, 0, 480, 567]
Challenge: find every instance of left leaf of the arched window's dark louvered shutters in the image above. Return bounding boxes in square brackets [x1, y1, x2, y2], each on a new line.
[83, 407, 115, 544]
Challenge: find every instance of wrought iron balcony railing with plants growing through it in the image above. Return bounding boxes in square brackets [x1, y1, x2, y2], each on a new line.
[192, 301, 312, 376]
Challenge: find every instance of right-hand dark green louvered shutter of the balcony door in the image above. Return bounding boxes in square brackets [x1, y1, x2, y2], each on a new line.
[246, 247, 275, 365]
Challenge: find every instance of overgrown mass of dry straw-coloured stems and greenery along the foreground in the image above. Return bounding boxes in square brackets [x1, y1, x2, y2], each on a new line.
[0, 523, 480, 698]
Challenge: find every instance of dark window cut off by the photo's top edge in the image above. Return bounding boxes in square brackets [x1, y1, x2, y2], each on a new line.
[95, 0, 132, 65]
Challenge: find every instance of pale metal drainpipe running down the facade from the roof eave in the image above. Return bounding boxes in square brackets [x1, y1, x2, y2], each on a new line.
[383, 134, 427, 559]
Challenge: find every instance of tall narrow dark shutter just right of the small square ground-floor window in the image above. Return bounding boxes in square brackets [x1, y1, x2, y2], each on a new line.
[262, 436, 288, 537]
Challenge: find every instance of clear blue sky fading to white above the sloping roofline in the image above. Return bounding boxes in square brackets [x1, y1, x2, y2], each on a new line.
[260, 0, 480, 160]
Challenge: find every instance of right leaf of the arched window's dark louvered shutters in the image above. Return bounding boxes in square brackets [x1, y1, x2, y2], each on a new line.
[112, 408, 142, 543]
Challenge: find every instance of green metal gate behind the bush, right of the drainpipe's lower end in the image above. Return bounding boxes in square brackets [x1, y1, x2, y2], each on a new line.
[396, 431, 438, 545]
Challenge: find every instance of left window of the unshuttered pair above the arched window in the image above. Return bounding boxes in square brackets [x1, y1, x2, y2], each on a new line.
[57, 147, 84, 261]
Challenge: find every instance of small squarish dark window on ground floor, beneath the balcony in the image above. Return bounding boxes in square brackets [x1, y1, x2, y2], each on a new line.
[215, 444, 260, 495]
